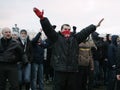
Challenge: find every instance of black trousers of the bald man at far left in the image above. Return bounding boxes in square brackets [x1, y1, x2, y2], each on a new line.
[0, 63, 19, 90]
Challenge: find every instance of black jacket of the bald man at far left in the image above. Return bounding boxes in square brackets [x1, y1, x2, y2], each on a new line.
[0, 38, 28, 63]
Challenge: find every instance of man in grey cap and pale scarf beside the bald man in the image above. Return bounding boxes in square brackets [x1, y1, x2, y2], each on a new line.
[18, 29, 33, 90]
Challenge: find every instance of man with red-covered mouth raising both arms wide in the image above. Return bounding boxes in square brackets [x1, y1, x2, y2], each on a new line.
[34, 8, 103, 90]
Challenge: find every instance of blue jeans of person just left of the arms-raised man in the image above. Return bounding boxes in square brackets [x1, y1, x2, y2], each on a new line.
[31, 63, 44, 90]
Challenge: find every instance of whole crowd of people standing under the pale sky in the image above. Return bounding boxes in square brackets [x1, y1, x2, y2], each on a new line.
[0, 8, 120, 90]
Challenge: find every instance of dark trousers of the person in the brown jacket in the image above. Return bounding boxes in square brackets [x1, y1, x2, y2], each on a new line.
[77, 66, 93, 90]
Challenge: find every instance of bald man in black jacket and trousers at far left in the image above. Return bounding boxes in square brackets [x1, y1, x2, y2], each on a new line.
[0, 27, 28, 90]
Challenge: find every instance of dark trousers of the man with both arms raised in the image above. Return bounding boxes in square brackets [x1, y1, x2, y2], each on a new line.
[53, 71, 76, 90]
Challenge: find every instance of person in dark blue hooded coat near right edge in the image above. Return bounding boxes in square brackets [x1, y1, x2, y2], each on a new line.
[107, 35, 118, 90]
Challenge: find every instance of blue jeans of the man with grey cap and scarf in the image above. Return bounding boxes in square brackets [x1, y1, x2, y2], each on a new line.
[18, 63, 31, 84]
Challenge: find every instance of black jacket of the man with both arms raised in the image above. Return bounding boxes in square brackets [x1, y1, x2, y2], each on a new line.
[40, 18, 96, 72]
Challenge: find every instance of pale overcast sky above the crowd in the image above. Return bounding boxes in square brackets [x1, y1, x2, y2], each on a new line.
[0, 0, 120, 34]
